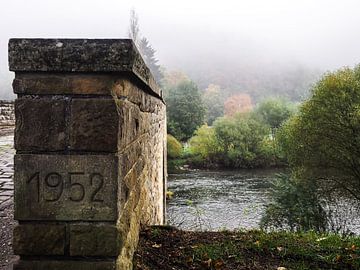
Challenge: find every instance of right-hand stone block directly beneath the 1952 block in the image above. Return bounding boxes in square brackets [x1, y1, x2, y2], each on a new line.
[70, 223, 120, 256]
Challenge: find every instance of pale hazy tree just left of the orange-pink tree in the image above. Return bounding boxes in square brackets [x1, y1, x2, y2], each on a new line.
[203, 84, 224, 125]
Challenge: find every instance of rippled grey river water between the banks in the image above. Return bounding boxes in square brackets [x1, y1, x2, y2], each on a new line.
[167, 170, 360, 234]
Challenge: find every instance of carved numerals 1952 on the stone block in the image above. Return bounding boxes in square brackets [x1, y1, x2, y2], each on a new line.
[26, 172, 104, 202]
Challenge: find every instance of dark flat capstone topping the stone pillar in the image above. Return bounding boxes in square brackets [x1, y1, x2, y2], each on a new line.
[9, 39, 161, 96]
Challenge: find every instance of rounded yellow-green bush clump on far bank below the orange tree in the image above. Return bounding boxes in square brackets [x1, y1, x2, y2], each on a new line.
[189, 114, 279, 168]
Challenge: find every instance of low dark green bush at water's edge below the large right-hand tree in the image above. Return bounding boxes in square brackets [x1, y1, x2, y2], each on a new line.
[261, 174, 331, 232]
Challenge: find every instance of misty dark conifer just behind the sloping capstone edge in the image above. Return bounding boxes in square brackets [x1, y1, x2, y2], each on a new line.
[139, 37, 163, 83]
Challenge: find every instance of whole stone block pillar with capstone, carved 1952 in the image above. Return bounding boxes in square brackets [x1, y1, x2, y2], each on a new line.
[9, 39, 166, 270]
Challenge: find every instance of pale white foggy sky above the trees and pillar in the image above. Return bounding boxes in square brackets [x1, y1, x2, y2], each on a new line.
[0, 0, 360, 98]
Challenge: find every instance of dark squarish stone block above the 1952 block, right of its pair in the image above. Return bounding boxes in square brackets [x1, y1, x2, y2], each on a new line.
[70, 99, 120, 152]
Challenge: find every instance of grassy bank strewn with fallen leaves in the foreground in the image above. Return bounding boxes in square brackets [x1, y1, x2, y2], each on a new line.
[134, 226, 360, 270]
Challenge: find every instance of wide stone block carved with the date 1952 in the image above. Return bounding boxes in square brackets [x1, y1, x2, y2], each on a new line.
[14, 155, 118, 221]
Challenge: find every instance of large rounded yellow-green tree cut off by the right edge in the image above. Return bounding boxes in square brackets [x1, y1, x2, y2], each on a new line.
[278, 66, 360, 201]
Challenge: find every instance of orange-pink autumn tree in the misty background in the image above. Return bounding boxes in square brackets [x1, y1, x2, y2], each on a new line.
[224, 94, 253, 116]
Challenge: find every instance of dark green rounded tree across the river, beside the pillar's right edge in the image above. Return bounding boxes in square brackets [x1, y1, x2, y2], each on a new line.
[167, 81, 205, 141]
